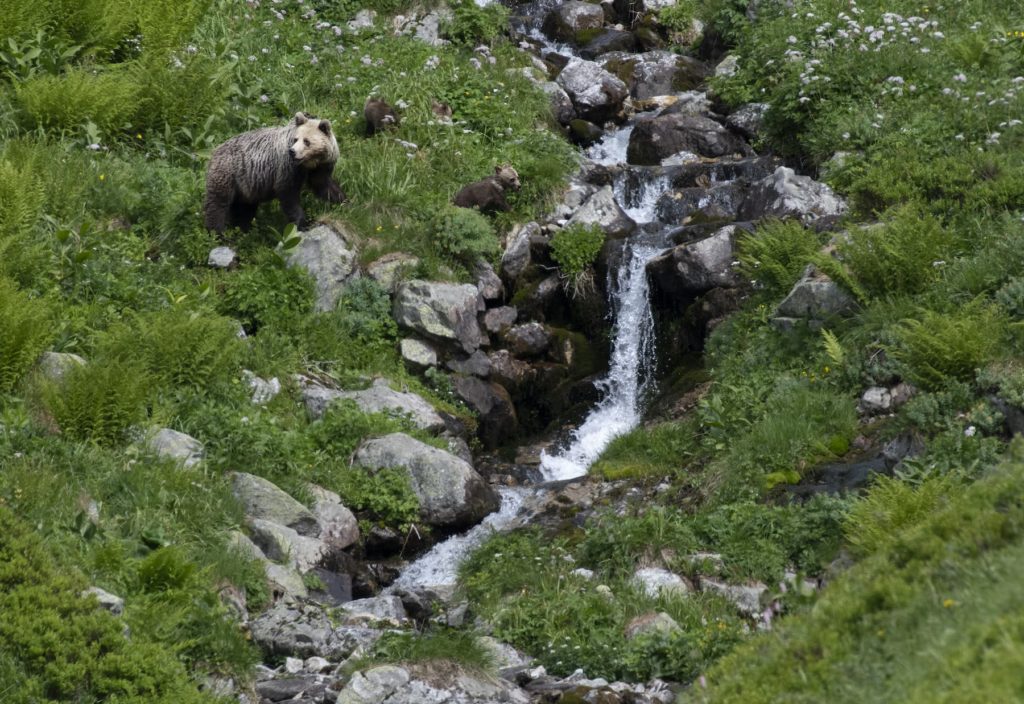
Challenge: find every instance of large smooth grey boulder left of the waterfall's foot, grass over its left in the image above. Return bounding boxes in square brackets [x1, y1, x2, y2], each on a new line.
[352, 433, 499, 528]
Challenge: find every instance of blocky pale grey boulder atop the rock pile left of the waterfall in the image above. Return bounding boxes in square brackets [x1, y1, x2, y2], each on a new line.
[393, 280, 482, 354]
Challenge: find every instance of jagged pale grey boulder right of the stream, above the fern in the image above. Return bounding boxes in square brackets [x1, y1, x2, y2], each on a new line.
[739, 166, 847, 224]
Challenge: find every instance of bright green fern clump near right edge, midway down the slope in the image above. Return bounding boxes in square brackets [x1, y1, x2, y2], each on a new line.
[892, 301, 1007, 389]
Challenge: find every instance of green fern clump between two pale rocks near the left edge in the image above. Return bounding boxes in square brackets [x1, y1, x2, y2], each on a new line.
[42, 359, 147, 445]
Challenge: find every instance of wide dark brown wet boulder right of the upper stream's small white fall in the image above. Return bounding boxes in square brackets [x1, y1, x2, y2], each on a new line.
[626, 113, 750, 166]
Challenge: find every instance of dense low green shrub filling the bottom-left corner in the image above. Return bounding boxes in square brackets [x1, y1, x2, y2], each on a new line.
[0, 508, 212, 704]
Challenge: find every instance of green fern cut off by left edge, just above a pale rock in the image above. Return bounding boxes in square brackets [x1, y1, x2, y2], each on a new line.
[0, 278, 53, 393]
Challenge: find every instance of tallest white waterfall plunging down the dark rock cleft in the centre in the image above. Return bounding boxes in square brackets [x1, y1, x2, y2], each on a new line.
[541, 245, 664, 481]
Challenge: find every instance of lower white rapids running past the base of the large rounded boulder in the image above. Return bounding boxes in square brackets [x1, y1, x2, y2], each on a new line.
[385, 486, 529, 593]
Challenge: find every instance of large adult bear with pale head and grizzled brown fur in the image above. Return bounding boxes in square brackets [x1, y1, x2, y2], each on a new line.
[203, 113, 345, 232]
